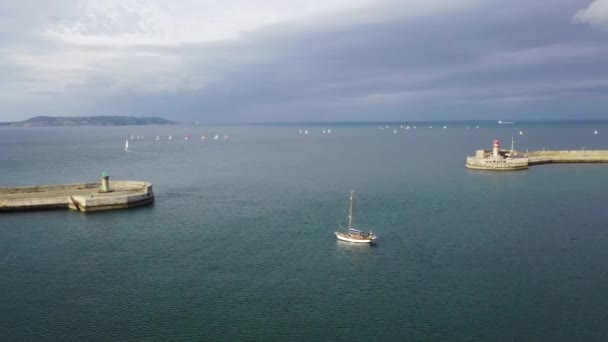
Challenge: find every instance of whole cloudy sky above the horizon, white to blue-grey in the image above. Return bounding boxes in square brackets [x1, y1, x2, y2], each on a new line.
[0, 0, 608, 123]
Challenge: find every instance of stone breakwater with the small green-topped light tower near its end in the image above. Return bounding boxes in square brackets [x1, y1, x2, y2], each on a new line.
[0, 181, 154, 212]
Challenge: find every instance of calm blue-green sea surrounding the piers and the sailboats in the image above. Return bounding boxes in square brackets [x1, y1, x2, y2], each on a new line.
[0, 122, 608, 341]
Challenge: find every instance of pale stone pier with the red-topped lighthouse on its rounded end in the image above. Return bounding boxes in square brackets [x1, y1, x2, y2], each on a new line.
[465, 140, 608, 171]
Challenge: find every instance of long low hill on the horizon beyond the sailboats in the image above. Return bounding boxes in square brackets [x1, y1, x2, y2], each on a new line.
[2, 116, 177, 127]
